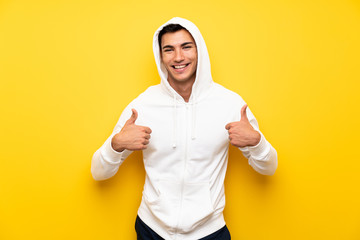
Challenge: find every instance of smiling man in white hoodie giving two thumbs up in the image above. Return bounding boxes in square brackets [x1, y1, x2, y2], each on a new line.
[91, 18, 277, 240]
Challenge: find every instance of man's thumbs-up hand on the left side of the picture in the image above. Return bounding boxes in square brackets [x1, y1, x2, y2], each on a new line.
[111, 109, 151, 152]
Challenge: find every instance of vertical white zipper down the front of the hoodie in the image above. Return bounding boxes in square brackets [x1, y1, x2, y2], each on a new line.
[175, 102, 189, 239]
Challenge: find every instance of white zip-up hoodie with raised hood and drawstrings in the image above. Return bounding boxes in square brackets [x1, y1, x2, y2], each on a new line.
[91, 18, 277, 240]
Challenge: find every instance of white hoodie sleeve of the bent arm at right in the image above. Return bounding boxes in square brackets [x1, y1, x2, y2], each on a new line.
[239, 108, 278, 175]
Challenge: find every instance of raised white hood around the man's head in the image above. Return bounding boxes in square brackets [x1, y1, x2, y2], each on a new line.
[153, 17, 213, 103]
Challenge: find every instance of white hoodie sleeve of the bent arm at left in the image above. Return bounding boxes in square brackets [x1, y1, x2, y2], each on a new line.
[91, 106, 132, 181]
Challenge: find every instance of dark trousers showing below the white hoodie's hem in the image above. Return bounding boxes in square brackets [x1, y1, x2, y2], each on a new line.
[135, 216, 231, 240]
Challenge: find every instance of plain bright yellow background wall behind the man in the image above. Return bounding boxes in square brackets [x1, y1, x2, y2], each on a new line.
[0, 0, 360, 240]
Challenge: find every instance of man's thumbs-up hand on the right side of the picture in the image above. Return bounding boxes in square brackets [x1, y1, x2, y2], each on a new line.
[225, 104, 261, 147]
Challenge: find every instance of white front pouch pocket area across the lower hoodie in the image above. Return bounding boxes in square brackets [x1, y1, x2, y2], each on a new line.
[144, 180, 214, 233]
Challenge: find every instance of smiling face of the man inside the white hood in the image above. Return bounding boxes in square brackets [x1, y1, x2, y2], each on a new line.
[160, 29, 197, 84]
